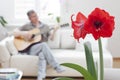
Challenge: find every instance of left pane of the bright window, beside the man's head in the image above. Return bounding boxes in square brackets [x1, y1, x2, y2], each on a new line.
[15, 0, 35, 19]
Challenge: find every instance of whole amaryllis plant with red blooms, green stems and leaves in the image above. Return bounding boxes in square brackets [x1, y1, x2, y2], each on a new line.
[55, 8, 115, 80]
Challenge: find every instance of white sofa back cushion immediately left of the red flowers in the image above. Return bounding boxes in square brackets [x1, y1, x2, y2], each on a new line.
[60, 27, 76, 49]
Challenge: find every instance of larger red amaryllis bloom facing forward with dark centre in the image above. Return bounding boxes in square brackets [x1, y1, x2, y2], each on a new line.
[84, 8, 115, 40]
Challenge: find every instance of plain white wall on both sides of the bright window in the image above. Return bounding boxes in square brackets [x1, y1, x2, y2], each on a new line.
[0, 0, 120, 57]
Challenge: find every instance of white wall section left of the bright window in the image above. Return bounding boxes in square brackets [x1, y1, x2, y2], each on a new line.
[0, 0, 26, 25]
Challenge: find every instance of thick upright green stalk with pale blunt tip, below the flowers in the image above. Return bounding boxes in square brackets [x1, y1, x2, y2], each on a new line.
[84, 42, 97, 80]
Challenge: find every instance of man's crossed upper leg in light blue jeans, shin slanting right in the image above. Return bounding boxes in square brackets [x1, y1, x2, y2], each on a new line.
[29, 42, 59, 68]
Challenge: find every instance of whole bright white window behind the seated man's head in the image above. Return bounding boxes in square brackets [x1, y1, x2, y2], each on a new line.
[15, 0, 60, 19]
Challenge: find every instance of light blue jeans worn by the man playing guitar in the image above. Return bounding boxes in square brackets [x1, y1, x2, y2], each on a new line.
[29, 42, 59, 78]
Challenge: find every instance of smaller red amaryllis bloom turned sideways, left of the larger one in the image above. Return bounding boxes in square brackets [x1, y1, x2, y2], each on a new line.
[71, 12, 87, 40]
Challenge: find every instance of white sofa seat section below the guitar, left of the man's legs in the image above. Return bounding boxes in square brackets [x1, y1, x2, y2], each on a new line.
[10, 54, 38, 76]
